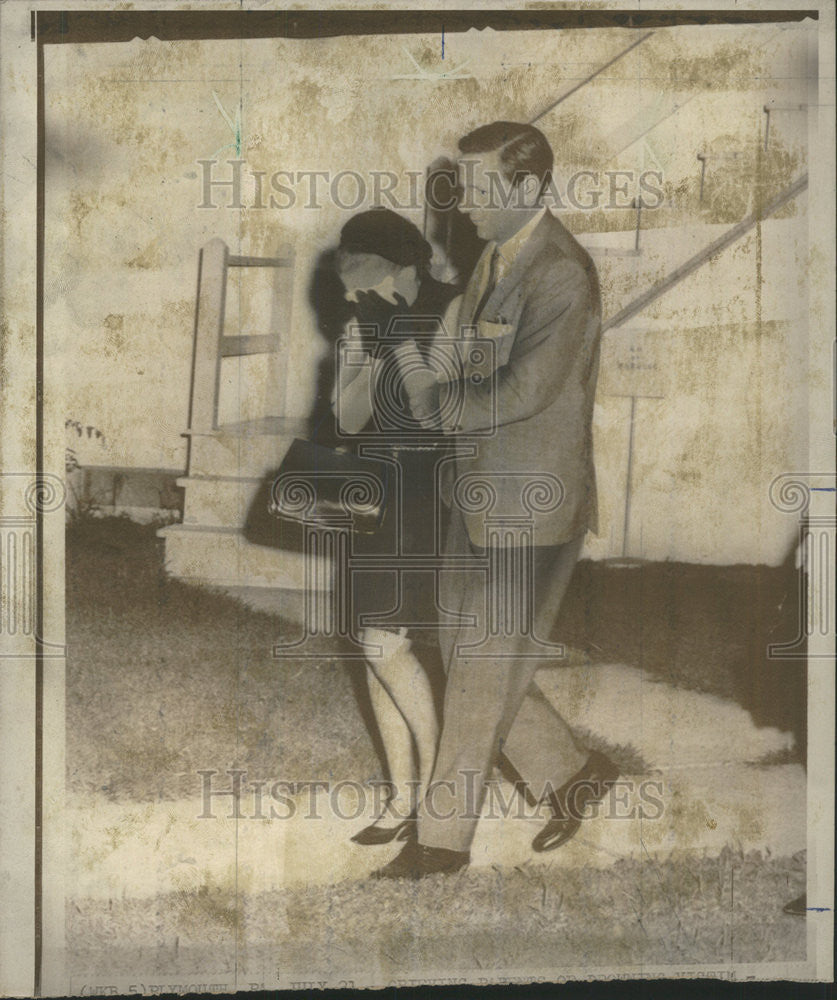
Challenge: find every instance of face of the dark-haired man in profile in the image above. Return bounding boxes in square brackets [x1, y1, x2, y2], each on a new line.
[456, 152, 531, 243]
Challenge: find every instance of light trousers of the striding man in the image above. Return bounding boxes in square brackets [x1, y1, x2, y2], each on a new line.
[418, 508, 587, 851]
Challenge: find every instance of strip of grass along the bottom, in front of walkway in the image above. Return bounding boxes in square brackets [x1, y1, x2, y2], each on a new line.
[69, 850, 805, 983]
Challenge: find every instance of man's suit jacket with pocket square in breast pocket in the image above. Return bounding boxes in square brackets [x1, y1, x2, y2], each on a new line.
[456, 211, 601, 545]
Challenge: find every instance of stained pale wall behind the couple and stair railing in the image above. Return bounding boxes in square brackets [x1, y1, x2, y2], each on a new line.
[46, 26, 807, 562]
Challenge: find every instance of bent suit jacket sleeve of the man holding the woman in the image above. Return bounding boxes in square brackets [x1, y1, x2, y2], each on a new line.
[457, 257, 599, 434]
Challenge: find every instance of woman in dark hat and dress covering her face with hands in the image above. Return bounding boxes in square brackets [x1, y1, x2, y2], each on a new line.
[333, 209, 458, 844]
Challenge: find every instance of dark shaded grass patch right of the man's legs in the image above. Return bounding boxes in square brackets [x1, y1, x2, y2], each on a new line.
[556, 555, 807, 759]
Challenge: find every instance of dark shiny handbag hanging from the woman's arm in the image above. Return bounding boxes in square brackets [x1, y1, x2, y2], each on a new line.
[243, 438, 395, 549]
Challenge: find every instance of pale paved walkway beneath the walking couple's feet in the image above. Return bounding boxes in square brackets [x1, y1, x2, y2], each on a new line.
[65, 665, 806, 899]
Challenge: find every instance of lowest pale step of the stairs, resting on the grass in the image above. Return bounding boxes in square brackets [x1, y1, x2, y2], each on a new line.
[158, 524, 331, 591]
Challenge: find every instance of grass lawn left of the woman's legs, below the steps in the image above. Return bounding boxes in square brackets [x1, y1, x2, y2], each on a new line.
[67, 519, 381, 801]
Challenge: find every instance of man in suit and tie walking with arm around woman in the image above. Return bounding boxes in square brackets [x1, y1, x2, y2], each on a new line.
[375, 122, 618, 878]
